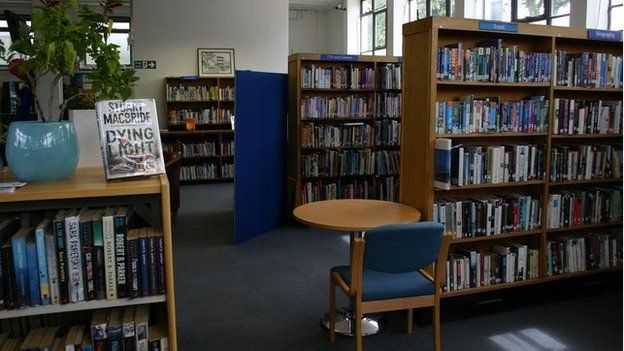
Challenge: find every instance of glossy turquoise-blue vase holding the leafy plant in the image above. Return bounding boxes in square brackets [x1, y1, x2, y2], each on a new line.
[6, 121, 79, 182]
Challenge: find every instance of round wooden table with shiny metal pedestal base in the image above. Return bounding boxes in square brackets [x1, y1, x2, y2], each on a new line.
[293, 199, 420, 336]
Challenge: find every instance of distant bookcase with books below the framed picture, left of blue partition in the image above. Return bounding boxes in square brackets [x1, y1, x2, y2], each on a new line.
[160, 77, 235, 184]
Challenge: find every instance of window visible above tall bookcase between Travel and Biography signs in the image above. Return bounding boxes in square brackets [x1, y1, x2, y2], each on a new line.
[511, 0, 570, 27]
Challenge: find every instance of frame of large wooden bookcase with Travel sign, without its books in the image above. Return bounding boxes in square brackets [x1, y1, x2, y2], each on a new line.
[400, 17, 622, 297]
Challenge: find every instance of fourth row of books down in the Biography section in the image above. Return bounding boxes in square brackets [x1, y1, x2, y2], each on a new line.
[547, 186, 622, 229]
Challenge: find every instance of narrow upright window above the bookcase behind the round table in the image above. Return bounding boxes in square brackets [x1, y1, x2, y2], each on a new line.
[360, 0, 388, 55]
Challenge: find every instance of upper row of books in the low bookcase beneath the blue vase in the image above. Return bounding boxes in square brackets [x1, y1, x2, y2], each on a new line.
[0, 212, 165, 309]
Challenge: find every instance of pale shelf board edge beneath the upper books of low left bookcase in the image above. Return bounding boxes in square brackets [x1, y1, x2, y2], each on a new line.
[0, 295, 167, 319]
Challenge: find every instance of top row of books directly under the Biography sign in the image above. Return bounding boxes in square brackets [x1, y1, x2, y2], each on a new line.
[555, 50, 622, 88]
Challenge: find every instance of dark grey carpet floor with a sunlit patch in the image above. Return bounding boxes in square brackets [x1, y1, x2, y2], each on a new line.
[174, 184, 622, 351]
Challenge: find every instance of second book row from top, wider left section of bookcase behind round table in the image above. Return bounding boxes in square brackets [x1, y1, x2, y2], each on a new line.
[300, 95, 373, 118]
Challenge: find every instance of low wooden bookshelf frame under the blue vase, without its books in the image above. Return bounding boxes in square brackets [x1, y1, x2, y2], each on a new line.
[0, 168, 177, 351]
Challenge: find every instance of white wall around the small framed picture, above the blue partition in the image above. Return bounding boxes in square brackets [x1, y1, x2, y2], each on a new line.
[132, 0, 288, 126]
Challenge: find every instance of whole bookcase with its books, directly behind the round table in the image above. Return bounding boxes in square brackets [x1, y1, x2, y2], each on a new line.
[287, 54, 401, 208]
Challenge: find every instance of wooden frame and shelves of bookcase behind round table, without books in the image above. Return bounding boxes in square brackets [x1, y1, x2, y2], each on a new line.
[287, 53, 401, 208]
